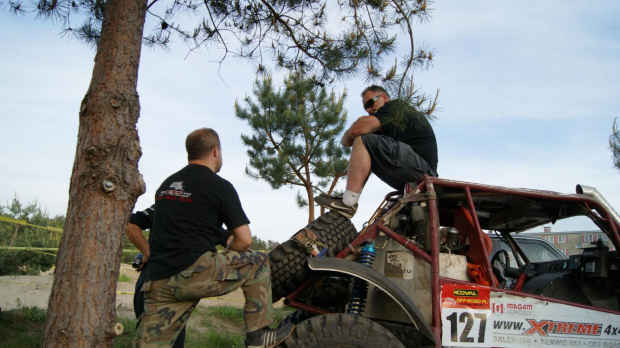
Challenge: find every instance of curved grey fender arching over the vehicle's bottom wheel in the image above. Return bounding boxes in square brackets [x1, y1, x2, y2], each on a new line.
[308, 257, 435, 344]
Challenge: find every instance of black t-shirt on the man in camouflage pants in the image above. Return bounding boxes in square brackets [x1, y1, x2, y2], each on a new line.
[147, 164, 250, 280]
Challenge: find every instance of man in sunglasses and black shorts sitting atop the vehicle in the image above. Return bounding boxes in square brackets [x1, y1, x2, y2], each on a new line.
[315, 85, 438, 218]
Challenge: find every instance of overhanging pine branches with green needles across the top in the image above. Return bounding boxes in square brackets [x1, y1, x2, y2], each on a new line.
[6, 0, 434, 108]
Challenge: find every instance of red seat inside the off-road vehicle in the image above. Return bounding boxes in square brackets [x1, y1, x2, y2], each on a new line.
[454, 207, 493, 272]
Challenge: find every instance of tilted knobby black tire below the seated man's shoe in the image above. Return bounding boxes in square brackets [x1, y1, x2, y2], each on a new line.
[269, 211, 357, 302]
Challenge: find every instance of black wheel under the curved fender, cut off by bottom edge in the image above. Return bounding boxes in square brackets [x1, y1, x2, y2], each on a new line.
[278, 313, 405, 348]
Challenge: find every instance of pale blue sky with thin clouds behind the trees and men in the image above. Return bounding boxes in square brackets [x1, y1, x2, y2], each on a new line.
[0, 0, 620, 242]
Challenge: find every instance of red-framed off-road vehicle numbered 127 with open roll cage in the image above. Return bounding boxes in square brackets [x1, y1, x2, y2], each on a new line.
[270, 176, 620, 348]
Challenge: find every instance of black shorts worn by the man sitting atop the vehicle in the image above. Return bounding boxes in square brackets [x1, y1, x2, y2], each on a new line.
[362, 133, 437, 190]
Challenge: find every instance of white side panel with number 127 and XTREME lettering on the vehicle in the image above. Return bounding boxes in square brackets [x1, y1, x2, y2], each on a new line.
[441, 290, 620, 348]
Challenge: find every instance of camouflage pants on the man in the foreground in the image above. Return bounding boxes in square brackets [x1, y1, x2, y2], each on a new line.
[133, 250, 273, 347]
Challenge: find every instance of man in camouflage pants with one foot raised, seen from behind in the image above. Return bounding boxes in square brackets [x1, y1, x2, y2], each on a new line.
[133, 128, 294, 347]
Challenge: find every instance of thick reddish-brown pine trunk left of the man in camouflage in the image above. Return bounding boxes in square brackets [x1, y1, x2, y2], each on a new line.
[43, 0, 146, 347]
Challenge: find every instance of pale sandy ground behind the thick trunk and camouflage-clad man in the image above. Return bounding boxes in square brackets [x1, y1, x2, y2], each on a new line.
[0, 264, 252, 318]
